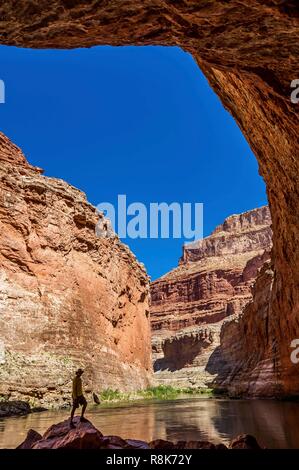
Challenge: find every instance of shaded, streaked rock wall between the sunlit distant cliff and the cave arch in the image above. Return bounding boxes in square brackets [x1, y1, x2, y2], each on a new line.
[216, 261, 282, 397]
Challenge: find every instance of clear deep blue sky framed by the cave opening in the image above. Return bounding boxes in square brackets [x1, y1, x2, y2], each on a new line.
[0, 46, 267, 279]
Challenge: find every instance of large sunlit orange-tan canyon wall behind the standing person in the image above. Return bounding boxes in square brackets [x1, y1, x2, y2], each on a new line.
[0, 133, 152, 405]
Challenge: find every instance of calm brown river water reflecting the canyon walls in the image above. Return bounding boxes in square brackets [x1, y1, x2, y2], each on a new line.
[0, 398, 299, 448]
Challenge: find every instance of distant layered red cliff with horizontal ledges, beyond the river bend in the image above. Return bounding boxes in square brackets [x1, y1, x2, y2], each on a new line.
[151, 206, 272, 387]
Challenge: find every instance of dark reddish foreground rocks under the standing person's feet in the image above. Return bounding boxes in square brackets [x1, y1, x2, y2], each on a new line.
[17, 417, 263, 450]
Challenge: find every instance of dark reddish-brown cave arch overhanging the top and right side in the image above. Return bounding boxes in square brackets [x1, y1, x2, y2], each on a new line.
[0, 0, 299, 394]
